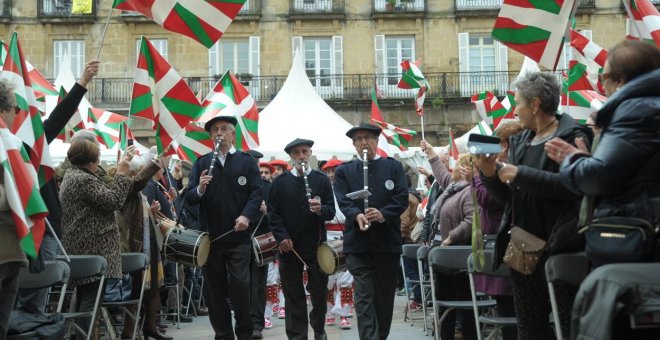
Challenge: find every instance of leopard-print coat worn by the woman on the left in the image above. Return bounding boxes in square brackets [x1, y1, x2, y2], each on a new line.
[60, 166, 133, 285]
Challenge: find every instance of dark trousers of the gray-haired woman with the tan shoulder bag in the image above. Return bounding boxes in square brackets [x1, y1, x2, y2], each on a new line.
[511, 266, 577, 340]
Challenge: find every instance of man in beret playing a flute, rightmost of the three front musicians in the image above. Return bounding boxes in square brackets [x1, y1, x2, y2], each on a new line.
[334, 123, 408, 340]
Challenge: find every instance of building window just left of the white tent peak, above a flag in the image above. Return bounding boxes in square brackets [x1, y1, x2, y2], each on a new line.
[209, 39, 251, 77]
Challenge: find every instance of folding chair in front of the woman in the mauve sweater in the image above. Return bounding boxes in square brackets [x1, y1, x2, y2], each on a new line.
[428, 246, 496, 339]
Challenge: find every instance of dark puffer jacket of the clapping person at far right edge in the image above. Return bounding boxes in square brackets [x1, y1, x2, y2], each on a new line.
[561, 69, 660, 223]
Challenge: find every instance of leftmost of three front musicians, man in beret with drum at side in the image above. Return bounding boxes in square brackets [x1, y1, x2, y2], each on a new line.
[186, 116, 263, 340]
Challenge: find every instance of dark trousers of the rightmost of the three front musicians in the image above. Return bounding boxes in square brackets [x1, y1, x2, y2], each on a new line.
[348, 253, 400, 340]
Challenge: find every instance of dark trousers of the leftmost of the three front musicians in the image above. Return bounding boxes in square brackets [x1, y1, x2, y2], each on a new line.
[204, 242, 252, 340]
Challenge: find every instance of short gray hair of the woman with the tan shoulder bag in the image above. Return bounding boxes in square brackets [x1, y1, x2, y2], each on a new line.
[513, 72, 561, 114]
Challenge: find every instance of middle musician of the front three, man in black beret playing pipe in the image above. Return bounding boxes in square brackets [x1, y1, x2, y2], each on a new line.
[268, 138, 335, 340]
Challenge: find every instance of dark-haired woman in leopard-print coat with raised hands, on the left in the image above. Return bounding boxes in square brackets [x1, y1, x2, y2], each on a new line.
[60, 139, 133, 338]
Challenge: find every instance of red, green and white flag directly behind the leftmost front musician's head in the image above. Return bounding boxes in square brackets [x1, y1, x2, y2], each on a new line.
[199, 71, 259, 151]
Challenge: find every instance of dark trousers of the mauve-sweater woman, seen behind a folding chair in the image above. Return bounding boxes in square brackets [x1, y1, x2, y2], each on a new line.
[435, 273, 477, 340]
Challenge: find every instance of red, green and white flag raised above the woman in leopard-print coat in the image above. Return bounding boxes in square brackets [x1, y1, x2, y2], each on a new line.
[130, 37, 202, 154]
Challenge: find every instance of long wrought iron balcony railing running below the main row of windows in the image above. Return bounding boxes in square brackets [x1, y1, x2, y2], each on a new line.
[82, 72, 544, 107]
